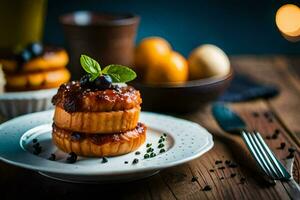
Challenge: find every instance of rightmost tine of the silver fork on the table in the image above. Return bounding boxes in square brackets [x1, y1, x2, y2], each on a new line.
[255, 131, 291, 180]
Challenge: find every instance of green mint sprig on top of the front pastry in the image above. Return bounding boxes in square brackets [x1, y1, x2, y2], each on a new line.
[80, 55, 136, 83]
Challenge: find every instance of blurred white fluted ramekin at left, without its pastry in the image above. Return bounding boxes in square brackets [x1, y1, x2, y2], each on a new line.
[0, 88, 57, 120]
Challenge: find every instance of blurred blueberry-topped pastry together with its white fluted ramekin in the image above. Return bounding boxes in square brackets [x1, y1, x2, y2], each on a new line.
[0, 43, 70, 120]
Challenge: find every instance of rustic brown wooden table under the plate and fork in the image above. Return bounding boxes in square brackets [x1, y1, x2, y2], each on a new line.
[0, 56, 300, 199]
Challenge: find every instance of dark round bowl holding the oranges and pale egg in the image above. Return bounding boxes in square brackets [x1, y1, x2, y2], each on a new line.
[131, 69, 233, 113]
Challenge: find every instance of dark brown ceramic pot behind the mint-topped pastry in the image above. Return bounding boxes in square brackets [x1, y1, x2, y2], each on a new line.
[60, 11, 140, 79]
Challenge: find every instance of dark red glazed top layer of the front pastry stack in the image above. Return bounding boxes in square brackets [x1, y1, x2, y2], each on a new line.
[52, 81, 142, 112]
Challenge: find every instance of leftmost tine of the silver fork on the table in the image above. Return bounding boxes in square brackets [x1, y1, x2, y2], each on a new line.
[242, 131, 274, 178]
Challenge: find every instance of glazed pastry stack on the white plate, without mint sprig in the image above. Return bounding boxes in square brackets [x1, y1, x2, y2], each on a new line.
[52, 81, 146, 157]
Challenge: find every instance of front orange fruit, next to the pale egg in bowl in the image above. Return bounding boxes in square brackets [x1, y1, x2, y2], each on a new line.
[145, 51, 189, 84]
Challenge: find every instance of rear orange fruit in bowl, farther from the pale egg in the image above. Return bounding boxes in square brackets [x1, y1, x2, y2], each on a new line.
[135, 37, 172, 71]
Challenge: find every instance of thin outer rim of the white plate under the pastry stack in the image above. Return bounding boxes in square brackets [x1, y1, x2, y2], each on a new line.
[0, 110, 214, 176]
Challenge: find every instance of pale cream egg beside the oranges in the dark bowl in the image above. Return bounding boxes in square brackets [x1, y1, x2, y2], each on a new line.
[188, 44, 230, 79]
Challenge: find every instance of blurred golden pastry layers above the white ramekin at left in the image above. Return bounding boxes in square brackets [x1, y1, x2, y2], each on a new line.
[0, 48, 70, 91]
